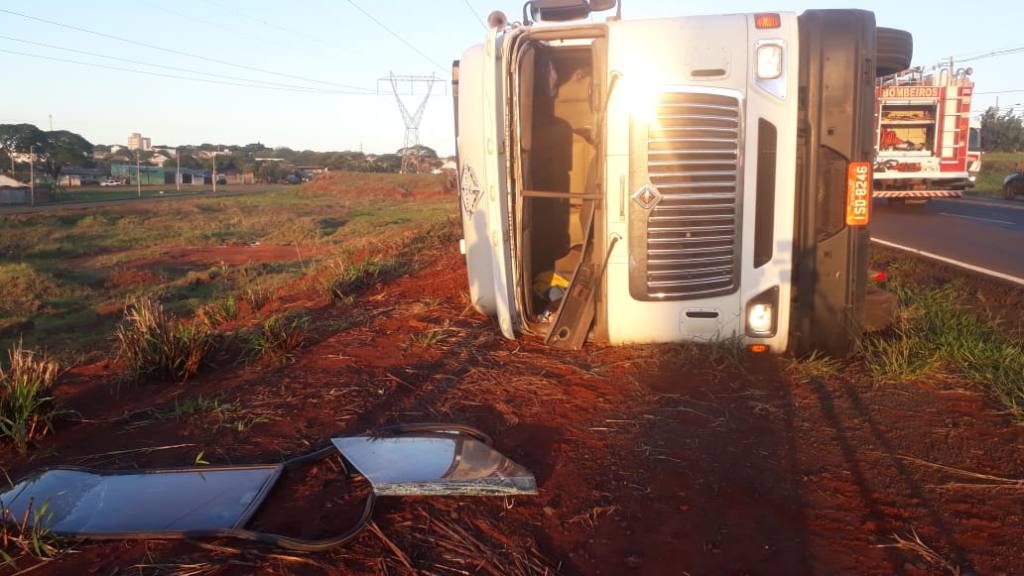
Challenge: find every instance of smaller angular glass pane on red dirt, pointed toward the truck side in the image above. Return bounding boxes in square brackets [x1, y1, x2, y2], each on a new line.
[331, 434, 537, 496]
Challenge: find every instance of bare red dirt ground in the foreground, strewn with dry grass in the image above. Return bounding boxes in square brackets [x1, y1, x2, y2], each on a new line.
[0, 248, 1024, 576]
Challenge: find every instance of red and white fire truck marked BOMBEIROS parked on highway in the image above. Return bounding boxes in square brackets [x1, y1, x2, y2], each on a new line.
[873, 65, 980, 203]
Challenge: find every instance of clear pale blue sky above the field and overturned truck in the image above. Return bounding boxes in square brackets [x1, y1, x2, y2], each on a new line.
[0, 0, 1024, 154]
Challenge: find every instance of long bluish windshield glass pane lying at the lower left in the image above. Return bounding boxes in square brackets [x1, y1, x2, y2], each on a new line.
[0, 465, 282, 535]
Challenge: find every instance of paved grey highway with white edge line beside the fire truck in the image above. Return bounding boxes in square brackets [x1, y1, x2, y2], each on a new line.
[871, 199, 1024, 283]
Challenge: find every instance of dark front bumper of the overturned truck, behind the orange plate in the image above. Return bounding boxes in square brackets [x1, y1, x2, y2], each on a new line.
[791, 10, 876, 356]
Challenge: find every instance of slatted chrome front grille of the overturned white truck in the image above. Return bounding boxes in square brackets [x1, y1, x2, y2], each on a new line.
[644, 92, 742, 299]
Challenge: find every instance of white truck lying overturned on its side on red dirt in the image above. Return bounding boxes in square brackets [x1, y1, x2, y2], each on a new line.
[454, 0, 910, 354]
